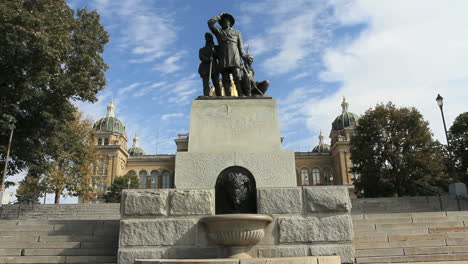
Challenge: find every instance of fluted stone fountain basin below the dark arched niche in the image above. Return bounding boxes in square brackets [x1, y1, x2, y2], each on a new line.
[200, 214, 273, 247]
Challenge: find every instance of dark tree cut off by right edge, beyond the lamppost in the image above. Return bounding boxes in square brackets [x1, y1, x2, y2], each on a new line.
[449, 112, 468, 184]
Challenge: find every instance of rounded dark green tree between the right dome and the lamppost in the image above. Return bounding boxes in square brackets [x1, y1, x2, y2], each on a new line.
[351, 102, 449, 197]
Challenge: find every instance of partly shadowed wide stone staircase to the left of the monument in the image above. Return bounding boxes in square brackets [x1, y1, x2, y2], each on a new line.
[0, 204, 120, 263]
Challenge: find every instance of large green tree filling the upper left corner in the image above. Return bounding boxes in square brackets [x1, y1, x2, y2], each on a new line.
[0, 0, 108, 188]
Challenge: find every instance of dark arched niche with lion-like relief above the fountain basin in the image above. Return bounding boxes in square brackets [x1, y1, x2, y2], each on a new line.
[215, 166, 257, 214]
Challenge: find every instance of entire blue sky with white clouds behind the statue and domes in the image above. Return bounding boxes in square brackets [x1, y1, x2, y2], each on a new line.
[5, 0, 468, 204]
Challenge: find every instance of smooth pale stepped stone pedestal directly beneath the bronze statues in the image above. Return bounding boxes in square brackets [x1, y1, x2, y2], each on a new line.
[175, 99, 296, 189]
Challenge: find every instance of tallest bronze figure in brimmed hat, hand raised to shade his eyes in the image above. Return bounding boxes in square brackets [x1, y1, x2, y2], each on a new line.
[208, 13, 251, 96]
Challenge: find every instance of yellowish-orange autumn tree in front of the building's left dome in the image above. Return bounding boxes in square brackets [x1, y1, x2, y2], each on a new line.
[43, 112, 99, 204]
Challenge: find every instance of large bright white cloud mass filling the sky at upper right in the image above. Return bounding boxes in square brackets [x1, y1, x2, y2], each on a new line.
[307, 0, 468, 143]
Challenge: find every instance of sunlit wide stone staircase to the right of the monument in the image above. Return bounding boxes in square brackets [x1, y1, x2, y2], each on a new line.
[352, 197, 468, 264]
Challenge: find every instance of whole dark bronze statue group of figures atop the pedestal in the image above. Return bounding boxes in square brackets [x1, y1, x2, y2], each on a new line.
[198, 13, 269, 97]
